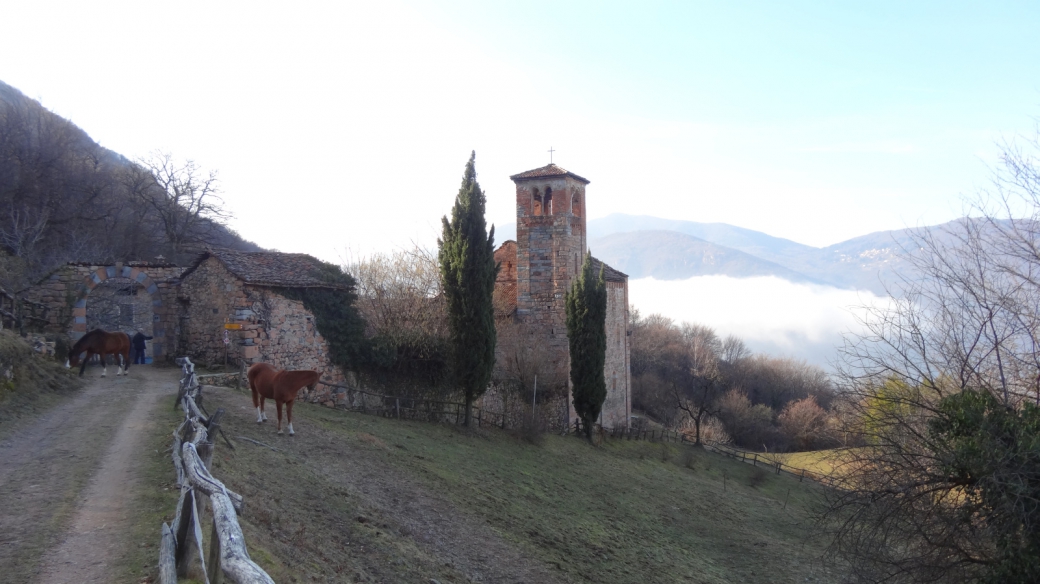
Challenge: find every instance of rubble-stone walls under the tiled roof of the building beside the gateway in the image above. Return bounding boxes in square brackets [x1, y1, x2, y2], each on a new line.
[178, 258, 344, 405]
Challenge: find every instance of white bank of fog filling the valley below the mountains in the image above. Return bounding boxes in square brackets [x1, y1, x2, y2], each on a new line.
[629, 275, 886, 370]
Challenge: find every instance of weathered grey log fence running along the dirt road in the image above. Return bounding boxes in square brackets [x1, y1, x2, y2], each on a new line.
[159, 357, 275, 584]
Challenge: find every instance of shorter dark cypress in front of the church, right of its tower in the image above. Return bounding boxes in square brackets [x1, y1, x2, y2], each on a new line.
[566, 254, 606, 441]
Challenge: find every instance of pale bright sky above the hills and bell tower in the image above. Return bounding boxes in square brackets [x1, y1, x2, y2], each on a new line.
[0, 0, 1040, 363]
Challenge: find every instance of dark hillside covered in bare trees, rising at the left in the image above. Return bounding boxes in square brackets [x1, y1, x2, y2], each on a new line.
[0, 81, 259, 291]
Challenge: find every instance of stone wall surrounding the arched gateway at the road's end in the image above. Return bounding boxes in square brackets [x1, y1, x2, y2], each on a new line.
[23, 262, 184, 361]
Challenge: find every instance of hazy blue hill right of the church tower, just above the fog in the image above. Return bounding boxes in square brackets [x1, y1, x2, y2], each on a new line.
[589, 230, 824, 284]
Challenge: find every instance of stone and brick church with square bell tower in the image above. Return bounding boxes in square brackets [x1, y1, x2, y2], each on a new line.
[495, 164, 631, 428]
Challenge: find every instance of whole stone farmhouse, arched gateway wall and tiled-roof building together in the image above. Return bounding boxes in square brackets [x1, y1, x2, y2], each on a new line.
[23, 250, 344, 402]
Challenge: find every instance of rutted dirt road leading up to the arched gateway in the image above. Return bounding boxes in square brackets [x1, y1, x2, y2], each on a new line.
[0, 366, 178, 584]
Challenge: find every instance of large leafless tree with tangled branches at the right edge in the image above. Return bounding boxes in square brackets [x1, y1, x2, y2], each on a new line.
[822, 129, 1040, 582]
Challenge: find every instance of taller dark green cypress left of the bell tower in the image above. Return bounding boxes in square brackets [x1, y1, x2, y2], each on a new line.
[437, 152, 498, 426]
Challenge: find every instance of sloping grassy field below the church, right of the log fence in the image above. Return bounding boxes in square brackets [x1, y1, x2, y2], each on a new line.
[176, 388, 839, 584]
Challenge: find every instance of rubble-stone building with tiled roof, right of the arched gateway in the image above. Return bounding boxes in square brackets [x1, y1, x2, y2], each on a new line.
[177, 250, 343, 405]
